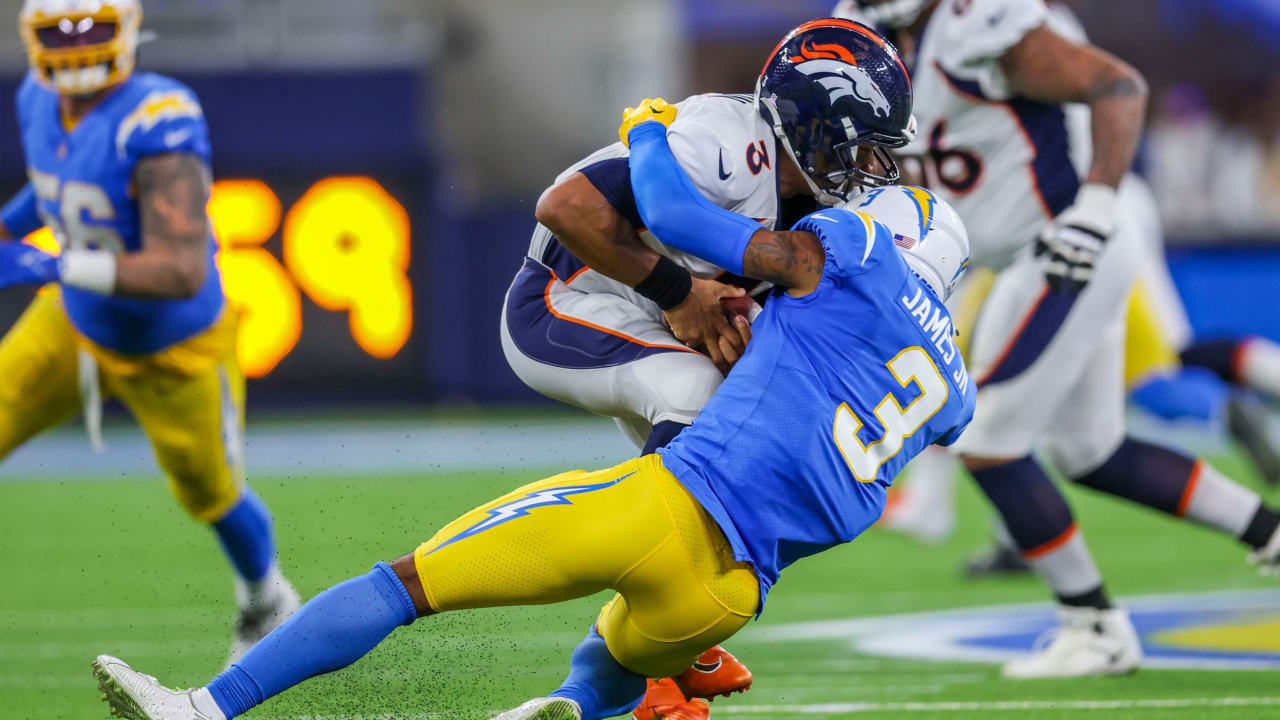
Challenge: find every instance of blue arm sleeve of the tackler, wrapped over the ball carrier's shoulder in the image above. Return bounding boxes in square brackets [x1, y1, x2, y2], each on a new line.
[628, 122, 763, 275]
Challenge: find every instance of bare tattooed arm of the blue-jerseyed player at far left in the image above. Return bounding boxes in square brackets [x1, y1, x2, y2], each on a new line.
[115, 152, 210, 299]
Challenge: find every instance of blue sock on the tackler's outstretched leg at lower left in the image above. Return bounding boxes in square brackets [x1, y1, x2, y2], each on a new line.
[209, 562, 417, 719]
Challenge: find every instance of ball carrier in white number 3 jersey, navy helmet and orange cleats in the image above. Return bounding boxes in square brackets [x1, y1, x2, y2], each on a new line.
[500, 19, 914, 720]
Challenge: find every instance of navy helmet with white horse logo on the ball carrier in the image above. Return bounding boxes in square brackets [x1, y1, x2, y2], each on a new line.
[755, 18, 915, 205]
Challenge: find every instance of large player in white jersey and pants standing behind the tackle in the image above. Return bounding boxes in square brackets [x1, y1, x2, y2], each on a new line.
[836, 0, 1280, 678]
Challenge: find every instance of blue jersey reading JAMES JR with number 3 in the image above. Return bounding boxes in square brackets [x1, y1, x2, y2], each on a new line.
[659, 210, 977, 607]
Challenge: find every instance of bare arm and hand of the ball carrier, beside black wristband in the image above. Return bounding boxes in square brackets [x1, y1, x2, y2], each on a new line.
[534, 173, 744, 370]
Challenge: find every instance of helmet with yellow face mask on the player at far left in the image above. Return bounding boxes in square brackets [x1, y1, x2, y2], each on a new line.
[18, 0, 142, 95]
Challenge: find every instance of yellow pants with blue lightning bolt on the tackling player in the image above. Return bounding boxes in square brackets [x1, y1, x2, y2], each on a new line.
[415, 455, 760, 678]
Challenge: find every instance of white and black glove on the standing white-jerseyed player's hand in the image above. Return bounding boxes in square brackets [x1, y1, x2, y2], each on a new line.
[1036, 182, 1116, 293]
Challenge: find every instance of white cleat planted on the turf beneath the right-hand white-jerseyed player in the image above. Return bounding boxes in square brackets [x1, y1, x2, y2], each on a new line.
[1002, 607, 1142, 679]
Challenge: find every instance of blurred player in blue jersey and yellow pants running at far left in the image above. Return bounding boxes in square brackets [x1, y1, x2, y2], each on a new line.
[0, 0, 300, 659]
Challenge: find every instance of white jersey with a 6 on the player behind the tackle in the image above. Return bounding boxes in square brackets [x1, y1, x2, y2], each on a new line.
[837, 0, 1091, 269]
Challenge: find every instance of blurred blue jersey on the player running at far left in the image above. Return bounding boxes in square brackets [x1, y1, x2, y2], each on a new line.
[18, 73, 223, 355]
